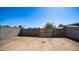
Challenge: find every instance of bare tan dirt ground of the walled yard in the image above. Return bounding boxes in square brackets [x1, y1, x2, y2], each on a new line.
[0, 37, 79, 51]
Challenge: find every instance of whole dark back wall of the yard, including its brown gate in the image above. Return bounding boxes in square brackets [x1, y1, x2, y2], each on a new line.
[19, 28, 64, 37]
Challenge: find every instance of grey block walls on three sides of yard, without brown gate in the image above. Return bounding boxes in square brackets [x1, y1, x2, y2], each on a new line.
[0, 26, 79, 41]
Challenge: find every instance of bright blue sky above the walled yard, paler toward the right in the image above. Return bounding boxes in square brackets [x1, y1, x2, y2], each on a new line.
[0, 7, 79, 27]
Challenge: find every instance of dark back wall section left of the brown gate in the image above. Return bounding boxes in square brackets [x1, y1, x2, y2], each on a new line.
[19, 28, 40, 36]
